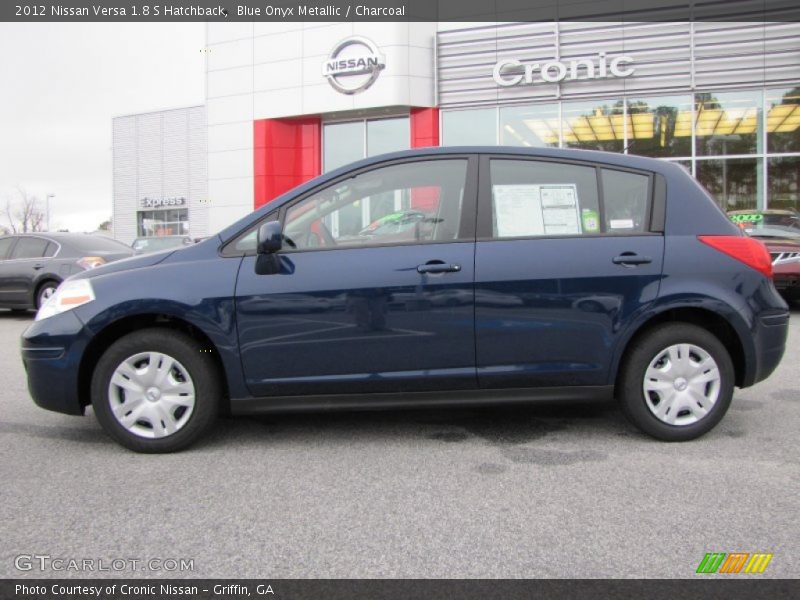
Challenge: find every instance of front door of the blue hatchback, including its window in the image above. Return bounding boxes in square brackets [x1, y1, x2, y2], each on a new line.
[236, 156, 477, 396]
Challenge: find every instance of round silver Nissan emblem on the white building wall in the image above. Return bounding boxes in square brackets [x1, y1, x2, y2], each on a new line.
[322, 36, 386, 94]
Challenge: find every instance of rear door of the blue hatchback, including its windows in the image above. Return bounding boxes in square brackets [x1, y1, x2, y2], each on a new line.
[475, 156, 664, 388]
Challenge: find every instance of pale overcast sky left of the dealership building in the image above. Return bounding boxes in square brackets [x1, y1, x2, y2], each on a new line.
[0, 23, 205, 231]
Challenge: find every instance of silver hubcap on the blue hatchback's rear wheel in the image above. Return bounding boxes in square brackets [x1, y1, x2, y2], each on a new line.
[642, 344, 722, 426]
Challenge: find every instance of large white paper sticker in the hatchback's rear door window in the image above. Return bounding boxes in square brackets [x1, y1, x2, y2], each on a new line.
[493, 184, 581, 238]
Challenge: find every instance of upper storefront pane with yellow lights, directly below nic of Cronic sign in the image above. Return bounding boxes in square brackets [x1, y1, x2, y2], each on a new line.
[561, 99, 625, 152]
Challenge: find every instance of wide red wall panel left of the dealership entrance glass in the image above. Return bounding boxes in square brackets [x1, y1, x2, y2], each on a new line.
[253, 117, 322, 208]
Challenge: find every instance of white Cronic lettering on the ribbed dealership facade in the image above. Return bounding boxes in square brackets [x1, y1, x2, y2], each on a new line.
[492, 52, 634, 87]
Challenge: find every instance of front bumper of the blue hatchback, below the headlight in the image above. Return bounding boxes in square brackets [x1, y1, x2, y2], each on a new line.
[20, 311, 89, 415]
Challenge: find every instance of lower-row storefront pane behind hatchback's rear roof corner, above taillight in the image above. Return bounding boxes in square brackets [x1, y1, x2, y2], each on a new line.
[696, 158, 764, 211]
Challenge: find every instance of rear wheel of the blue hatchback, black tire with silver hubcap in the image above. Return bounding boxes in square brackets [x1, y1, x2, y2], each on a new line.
[617, 323, 734, 442]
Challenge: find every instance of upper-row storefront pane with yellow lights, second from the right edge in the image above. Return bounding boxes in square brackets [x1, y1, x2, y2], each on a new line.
[694, 90, 761, 156]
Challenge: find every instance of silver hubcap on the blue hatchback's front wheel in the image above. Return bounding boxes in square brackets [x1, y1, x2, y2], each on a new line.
[108, 352, 195, 438]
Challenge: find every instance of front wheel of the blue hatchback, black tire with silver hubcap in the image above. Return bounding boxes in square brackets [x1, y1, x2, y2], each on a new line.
[91, 328, 222, 453]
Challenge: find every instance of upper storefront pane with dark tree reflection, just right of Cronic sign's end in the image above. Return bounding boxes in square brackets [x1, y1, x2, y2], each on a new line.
[627, 95, 692, 158]
